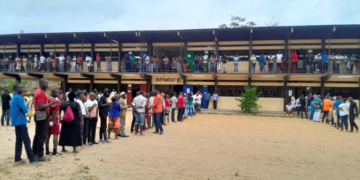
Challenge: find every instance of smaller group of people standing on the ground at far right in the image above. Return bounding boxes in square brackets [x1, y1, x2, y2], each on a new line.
[285, 94, 359, 133]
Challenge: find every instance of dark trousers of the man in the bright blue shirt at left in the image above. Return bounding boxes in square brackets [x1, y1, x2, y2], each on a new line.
[15, 125, 35, 162]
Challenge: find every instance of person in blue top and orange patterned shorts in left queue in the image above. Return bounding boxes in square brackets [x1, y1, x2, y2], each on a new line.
[108, 96, 121, 139]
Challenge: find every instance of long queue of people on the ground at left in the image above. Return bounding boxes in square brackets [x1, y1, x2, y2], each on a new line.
[1, 78, 218, 166]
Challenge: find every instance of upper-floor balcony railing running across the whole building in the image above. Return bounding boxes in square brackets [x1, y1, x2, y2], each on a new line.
[0, 59, 360, 74]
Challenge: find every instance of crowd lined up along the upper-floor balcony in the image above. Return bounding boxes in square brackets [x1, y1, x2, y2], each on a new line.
[0, 51, 360, 73]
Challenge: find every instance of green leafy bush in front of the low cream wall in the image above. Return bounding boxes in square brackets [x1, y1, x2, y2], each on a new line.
[236, 86, 262, 112]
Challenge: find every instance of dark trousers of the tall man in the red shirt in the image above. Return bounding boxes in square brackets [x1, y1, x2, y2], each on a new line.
[33, 119, 49, 157]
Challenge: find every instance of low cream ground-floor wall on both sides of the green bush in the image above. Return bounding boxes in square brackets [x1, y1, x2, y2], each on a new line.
[209, 96, 284, 112]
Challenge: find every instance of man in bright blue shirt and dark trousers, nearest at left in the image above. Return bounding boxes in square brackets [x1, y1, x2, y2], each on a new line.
[10, 83, 41, 166]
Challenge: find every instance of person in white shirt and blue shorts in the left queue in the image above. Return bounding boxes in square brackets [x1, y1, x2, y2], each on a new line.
[132, 91, 146, 135]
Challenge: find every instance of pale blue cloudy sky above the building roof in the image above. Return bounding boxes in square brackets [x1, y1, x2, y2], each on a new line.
[0, 0, 360, 34]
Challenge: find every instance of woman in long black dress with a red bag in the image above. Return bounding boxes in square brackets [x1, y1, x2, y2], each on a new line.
[59, 92, 83, 153]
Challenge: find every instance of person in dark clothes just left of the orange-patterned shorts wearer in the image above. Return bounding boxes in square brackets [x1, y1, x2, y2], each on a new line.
[98, 88, 111, 144]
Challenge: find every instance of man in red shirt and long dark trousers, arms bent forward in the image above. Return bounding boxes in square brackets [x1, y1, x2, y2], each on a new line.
[32, 78, 57, 161]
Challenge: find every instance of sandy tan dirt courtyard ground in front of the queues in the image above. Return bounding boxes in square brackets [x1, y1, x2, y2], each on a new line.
[0, 113, 360, 180]
